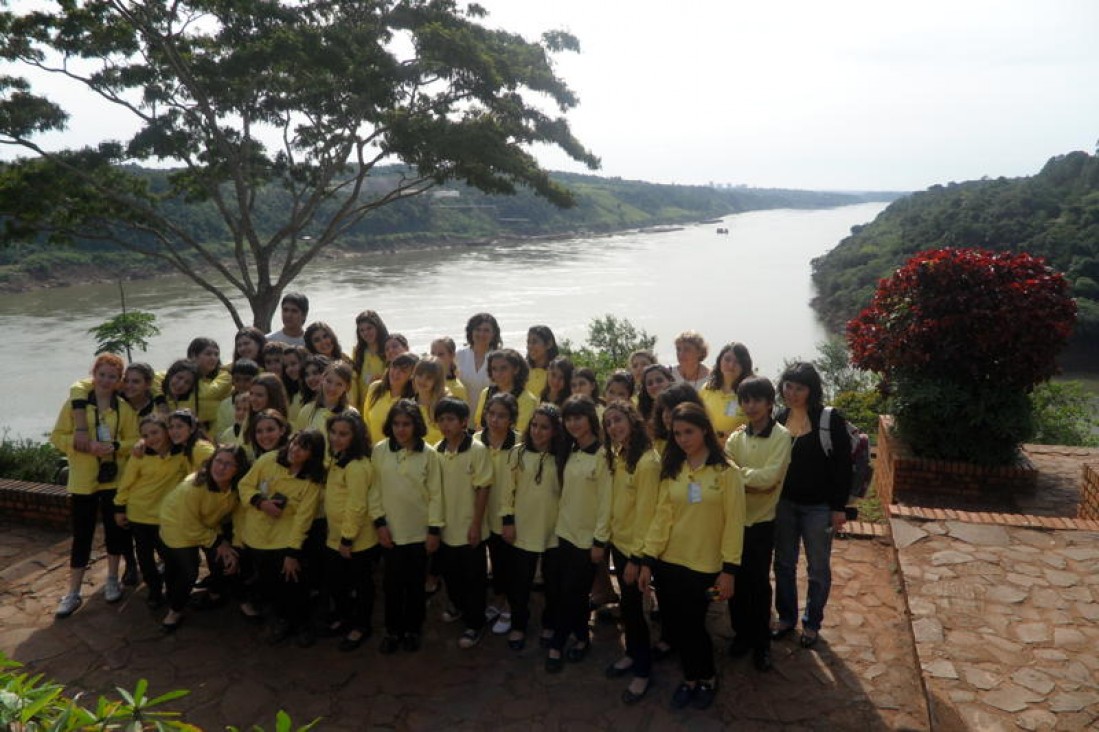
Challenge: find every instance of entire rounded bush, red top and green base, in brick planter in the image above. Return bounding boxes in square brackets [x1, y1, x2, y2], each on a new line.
[847, 248, 1076, 465]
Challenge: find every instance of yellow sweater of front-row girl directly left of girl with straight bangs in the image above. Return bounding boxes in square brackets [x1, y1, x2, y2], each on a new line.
[503, 445, 560, 554]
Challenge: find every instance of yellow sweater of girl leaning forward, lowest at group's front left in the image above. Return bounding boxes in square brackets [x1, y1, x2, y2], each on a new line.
[160, 476, 246, 548]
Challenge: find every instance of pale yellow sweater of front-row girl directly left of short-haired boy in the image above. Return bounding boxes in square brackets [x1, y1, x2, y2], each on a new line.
[368, 440, 446, 544]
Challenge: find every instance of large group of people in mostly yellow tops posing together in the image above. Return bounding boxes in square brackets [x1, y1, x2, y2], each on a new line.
[53, 311, 850, 708]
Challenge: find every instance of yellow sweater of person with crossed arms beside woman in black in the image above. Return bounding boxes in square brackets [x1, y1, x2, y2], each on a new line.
[725, 421, 793, 526]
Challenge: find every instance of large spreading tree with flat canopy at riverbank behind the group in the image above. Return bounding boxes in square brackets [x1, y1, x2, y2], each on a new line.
[0, 0, 599, 329]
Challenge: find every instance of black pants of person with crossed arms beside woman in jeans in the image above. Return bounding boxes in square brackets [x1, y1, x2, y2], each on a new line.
[729, 521, 775, 651]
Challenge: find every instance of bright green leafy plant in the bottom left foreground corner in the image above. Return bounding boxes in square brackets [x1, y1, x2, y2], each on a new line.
[0, 652, 320, 732]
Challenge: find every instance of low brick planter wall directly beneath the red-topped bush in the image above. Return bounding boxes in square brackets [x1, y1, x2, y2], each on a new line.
[874, 414, 1037, 507]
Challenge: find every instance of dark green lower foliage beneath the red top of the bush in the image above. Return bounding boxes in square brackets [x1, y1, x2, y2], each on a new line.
[890, 375, 1035, 465]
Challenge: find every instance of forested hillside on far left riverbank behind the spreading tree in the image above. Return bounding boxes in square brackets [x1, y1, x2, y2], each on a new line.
[0, 168, 899, 287]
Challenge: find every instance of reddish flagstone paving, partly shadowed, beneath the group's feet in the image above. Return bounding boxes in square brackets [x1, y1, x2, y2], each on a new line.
[0, 522, 929, 732]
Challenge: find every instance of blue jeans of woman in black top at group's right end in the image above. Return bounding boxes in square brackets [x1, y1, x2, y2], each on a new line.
[775, 500, 832, 631]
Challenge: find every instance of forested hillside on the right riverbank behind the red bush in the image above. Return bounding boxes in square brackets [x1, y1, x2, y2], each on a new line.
[812, 152, 1099, 362]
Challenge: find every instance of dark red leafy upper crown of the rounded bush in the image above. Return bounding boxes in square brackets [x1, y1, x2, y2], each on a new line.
[847, 248, 1076, 390]
